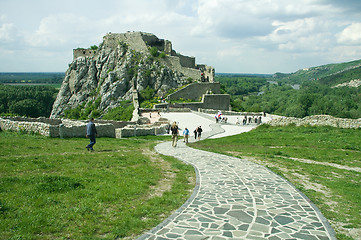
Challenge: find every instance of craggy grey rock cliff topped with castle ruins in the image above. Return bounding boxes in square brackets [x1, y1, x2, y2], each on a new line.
[51, 32, 214, 118]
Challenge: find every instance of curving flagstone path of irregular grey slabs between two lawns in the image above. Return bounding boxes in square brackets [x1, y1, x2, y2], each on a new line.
[138, 112, 336, 240]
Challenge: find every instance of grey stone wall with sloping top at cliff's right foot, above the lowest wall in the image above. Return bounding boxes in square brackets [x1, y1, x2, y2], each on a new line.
[168, 83, 221, 101]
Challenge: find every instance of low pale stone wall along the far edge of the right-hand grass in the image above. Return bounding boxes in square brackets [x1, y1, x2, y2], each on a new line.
[267, 115, 361, 128]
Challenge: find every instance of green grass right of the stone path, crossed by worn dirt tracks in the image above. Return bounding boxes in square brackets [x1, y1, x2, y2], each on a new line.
[191, 125, 361, 239]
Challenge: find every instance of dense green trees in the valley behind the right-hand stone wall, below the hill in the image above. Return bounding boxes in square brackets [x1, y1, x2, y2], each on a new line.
[220, 78, 361, 119]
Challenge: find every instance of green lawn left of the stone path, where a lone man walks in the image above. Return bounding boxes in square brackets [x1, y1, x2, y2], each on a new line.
[0, 132, 195, 239]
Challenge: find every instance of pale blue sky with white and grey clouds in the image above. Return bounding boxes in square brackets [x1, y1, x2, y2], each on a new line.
[0, 0, 361, 74]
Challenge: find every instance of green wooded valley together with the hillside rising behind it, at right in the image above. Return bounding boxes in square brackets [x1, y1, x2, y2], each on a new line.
[216, 60, 361, 118]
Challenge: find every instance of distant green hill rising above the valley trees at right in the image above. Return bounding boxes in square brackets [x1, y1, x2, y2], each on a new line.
[273, 60, 361, 86]
